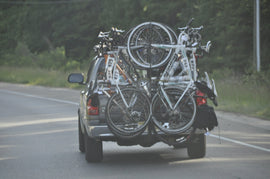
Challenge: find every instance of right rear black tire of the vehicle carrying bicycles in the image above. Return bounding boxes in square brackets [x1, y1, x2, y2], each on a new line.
[187, 134, 206, 158]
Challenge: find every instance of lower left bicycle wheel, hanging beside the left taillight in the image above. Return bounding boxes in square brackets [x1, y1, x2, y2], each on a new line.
[106, 88, 151, 138]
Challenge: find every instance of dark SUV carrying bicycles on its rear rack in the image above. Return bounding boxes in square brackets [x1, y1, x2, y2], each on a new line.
[68, 57, 206, 162]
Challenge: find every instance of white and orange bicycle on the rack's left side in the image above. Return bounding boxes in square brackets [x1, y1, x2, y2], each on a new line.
[94, 29, 151, 138]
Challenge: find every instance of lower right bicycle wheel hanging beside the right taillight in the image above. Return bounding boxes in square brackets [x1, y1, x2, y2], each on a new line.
[152, 87, 196, 134]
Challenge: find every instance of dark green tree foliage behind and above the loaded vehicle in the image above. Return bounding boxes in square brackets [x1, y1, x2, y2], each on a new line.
[0, 0, 270, 73]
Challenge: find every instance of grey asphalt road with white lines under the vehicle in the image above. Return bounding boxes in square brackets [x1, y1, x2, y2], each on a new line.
[0, 83, 270, 179]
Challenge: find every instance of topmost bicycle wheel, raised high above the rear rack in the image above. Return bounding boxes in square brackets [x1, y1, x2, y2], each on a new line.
[127, 22, 175, 68]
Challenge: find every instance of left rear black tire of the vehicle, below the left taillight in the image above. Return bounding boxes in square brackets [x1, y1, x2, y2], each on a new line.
[84, 134, 103, 162]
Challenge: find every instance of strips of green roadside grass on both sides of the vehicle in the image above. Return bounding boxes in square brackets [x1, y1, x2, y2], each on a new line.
[0, 66, 270, 120]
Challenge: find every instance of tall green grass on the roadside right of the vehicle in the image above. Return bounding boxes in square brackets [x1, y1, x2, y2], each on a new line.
[213, 70, 270, 120]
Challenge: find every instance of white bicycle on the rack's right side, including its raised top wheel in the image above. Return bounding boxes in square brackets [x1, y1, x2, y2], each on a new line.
[127, 20, 215, 134]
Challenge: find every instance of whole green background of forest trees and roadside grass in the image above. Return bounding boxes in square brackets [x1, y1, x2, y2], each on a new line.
[0, 0, 270, 118]
